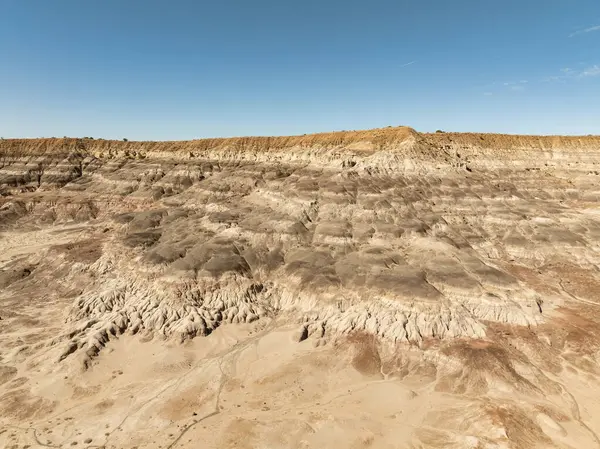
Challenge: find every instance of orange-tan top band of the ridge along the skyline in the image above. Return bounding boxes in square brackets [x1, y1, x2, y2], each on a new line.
[0, 127, 600, 155]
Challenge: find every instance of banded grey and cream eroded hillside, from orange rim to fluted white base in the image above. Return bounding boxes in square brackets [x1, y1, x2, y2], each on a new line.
[0, 128, 600, 356]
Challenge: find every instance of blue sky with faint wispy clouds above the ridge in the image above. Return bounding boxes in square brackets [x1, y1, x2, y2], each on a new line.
[0, 0, 600, 140]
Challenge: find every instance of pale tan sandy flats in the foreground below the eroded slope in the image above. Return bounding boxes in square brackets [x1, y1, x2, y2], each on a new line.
[0, 226, 600, 448]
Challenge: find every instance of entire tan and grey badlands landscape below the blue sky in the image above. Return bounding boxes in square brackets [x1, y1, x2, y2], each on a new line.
[0, 128, 600, 449]
